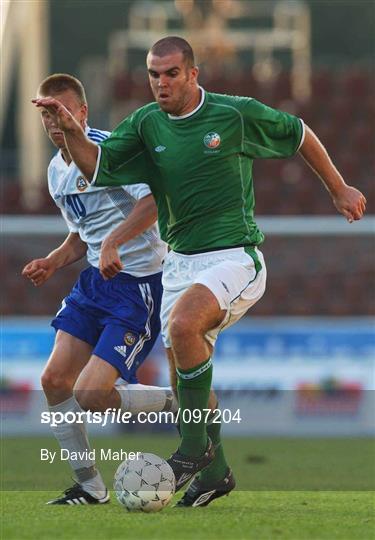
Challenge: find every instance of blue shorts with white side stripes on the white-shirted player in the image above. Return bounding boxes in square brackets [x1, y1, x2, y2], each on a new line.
[51, 266, 163, 384]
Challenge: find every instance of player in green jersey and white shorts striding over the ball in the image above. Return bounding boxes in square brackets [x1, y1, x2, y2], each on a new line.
[35, 37, 366, 506]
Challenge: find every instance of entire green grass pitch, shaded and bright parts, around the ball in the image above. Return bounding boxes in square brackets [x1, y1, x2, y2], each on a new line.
[1, 434, 375, 540]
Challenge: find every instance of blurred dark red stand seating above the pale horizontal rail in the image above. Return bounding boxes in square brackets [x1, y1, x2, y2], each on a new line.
[0, 68, 375, 215]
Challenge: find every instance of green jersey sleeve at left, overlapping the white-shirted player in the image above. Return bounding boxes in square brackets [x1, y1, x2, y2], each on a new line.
[93, 115, 147, 186]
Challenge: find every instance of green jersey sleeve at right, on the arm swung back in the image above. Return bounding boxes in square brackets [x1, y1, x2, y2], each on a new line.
[240, 98, 305, 159]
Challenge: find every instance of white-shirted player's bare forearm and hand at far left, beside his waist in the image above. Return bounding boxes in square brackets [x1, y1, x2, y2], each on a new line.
[22, 233, 87, 287]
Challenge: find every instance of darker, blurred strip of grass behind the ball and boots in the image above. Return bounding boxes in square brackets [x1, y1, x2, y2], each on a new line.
[1, 433, 375, 493]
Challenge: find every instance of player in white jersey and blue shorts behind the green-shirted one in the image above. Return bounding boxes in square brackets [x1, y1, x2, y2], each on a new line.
[23, 74, 175, 505]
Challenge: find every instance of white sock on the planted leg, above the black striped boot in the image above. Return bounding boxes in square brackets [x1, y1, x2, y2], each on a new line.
[49, 396, 107, 499]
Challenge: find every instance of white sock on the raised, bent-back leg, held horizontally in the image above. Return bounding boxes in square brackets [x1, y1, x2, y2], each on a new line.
[115, 383, 178, 414]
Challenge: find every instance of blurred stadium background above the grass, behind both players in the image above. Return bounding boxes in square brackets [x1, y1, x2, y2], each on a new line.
[0, 0, 375, 468]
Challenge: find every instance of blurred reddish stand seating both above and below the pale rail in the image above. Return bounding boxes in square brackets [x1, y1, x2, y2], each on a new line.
[0, 65, 375, 316]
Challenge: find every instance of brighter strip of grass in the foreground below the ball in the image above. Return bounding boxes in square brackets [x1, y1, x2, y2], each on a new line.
[1, 491, 375, 540]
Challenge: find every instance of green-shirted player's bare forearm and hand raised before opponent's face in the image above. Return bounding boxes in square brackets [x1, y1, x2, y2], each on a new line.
[32, 97, 98, 182]
